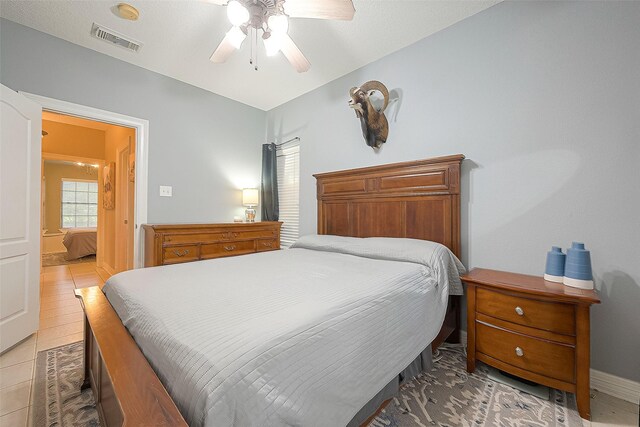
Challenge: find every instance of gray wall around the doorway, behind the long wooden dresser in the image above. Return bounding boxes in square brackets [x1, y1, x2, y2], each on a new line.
[0, 19, 266, 222]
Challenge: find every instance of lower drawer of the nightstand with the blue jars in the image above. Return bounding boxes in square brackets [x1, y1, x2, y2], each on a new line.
[476, 322, 575, 383]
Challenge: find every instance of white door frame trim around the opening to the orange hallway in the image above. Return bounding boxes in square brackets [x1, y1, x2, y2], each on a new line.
[19, 92, 149, 268]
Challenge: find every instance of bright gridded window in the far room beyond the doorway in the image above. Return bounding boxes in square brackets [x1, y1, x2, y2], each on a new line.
[60, 179, 98, 228]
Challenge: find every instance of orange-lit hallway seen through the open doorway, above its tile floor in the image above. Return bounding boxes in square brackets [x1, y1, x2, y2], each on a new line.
[42, 111, 136, 275]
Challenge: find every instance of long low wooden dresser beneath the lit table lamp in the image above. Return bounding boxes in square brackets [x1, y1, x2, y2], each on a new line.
[143, 221, 282, 267]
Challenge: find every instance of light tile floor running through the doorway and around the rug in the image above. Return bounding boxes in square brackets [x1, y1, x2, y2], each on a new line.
[0, 263, 638, 427]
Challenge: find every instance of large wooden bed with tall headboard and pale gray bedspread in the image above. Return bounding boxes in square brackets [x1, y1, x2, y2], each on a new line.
[77, 156, 463, 426]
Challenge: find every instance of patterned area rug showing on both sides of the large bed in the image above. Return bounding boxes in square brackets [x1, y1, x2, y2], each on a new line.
[34, 342, 582, 427]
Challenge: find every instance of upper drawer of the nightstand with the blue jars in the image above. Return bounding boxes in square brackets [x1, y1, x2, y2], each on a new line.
[476, 288, 576, 335]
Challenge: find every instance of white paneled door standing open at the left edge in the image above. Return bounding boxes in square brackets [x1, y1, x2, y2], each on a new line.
[0, 85, 42, 352]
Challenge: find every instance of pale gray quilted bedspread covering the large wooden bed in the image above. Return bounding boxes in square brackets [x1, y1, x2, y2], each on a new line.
[104, 237, 464, 427]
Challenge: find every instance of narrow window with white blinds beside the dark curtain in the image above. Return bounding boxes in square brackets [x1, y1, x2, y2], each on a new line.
[276, 141, 300, 248]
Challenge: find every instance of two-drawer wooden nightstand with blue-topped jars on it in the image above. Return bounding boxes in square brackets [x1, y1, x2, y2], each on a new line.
[462, 268, 600, 419]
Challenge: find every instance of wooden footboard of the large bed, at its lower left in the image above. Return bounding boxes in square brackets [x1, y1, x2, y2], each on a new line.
[75, 286, 187, 427]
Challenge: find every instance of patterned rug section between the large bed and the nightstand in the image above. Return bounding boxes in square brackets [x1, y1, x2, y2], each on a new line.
[370, 349, 582, 427]
